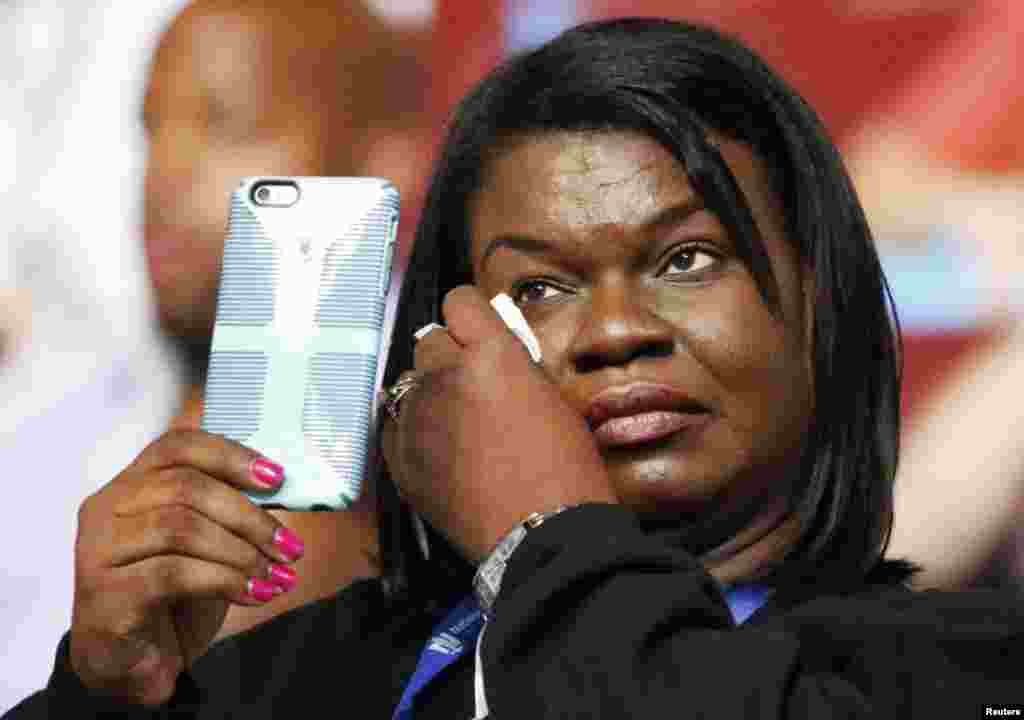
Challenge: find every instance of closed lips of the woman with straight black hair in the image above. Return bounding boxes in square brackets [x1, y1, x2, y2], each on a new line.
[586, 382, 711, 448]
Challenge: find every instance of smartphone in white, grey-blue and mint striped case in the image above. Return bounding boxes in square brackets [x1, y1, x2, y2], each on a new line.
[201, 177, 404, 510]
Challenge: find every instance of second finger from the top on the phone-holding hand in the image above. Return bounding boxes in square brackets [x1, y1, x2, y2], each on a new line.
[114, 467, 298, 562]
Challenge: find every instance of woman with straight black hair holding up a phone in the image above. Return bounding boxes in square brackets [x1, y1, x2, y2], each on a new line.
[14, 14, 1024, 718]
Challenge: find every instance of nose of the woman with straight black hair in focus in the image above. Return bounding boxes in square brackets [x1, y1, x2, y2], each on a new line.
[569, 283, 675, 374]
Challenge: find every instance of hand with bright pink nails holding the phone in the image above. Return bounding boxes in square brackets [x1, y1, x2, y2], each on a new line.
[69, 429, 303, 705]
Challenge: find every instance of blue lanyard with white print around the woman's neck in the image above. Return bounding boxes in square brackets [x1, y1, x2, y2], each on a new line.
[391, 585, 771, 720]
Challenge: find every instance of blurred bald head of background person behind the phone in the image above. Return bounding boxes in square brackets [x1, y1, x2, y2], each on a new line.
[144, 2, 423, 373]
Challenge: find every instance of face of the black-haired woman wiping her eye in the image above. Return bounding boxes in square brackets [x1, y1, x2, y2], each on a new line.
[470, 132, 812, 565]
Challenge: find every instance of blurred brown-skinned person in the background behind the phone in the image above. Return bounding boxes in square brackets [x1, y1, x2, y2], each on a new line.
[137, 0, 429, 636]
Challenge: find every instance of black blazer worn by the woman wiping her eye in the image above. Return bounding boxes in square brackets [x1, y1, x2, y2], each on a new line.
[5, 506, 1024, 720]
